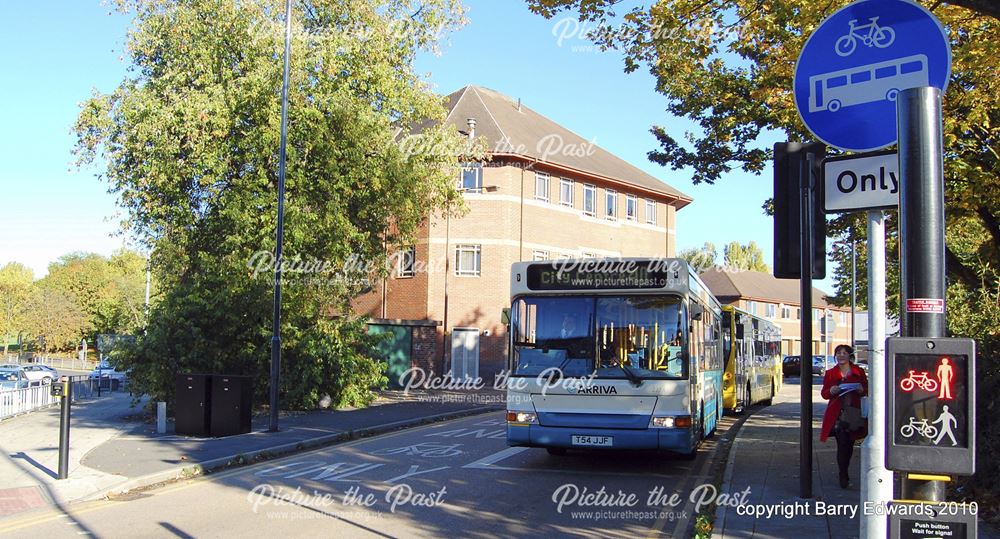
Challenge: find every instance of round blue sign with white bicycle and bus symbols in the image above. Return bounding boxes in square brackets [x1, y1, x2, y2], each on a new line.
[794, 0, 951, 152]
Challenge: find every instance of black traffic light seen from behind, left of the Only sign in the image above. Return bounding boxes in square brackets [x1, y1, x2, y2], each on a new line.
[774, 142, 826, 279]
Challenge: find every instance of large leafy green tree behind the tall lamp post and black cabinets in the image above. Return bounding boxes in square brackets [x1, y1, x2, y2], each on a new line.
[76, 0, 480, 412]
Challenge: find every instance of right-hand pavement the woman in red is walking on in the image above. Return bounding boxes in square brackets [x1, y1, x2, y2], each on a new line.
[713, 378, 1000, 539]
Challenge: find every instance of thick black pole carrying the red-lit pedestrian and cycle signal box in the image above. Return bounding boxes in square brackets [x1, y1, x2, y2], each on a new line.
[896, 87, 946, 502]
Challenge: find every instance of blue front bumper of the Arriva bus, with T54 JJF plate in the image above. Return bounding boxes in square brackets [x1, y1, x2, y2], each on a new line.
[507, 425, 695, 453]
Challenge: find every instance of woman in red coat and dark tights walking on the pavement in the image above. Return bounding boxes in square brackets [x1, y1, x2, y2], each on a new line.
[820, 344, 868, 488]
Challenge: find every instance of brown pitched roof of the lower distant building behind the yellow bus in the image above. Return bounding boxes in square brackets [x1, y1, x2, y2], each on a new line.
[700, 268, 840, 309]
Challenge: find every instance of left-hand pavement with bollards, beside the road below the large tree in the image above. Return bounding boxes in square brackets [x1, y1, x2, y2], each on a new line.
[0, 390, 503, 520]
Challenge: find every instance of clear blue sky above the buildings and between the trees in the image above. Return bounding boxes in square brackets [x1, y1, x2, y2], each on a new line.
[0, 0, 833, 291]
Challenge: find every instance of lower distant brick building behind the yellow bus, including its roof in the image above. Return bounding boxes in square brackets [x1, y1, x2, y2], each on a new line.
[701, 269, 851, 355]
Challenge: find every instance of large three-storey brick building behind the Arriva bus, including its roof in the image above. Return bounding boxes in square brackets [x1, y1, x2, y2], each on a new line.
[354, 86, 692, 381]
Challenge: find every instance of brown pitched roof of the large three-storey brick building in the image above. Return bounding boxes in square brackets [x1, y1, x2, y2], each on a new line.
[445, 86, 692, 208]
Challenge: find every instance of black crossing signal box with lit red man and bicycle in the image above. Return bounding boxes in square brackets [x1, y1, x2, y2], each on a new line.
[885, 337, 976, 475]
